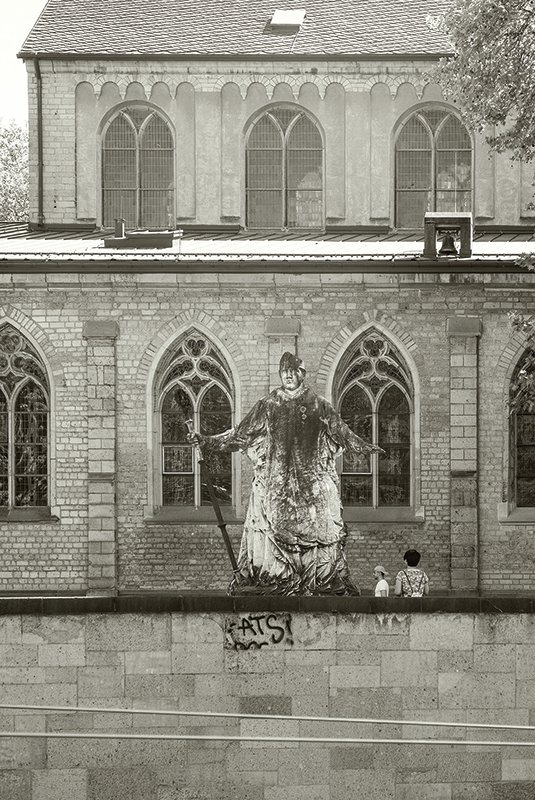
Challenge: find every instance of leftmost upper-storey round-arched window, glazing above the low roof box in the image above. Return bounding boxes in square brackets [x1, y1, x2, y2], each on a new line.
[102, 106, 174, 228]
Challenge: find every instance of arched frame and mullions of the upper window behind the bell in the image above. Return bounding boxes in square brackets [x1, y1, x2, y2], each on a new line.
[392, 102, 475, 230]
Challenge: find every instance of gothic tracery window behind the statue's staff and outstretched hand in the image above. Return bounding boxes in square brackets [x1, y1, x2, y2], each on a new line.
[156, 331, 237, 506]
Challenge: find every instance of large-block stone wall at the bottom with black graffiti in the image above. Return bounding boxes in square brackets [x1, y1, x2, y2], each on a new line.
[0, 601, 535, 800]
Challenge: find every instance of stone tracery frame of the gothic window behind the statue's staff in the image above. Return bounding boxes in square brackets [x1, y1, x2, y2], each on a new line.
[154, 329, 236, 521]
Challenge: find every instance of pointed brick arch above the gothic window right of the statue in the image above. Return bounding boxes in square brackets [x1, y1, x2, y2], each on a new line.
[318, 309, 423, 396]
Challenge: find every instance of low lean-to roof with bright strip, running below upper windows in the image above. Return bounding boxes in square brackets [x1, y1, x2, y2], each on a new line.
[0, 223, 535, 272]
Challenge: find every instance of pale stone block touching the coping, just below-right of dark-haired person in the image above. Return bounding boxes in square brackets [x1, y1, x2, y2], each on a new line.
[410, 614, 474, 650]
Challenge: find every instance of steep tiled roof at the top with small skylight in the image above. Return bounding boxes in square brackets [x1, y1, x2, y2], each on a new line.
[19, 0, 450, 57]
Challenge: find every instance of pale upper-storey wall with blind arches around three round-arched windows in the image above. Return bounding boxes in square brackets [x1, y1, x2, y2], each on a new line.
[24, 59, 535, 225]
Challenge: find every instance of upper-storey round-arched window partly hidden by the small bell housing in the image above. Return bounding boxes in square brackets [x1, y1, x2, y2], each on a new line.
[396, 108, 472, 228]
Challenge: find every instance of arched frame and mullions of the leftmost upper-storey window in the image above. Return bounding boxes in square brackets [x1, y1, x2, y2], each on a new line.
[98, 100, 176, 229]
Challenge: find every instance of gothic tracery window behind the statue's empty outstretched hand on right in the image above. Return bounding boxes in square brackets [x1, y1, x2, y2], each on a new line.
[337, 331, 413, 508]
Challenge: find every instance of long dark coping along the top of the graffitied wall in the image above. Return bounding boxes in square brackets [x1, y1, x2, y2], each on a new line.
[0, 592, 535, 615]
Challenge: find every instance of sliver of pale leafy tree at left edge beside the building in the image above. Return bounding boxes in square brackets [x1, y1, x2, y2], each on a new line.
[0, 120, 28, 222]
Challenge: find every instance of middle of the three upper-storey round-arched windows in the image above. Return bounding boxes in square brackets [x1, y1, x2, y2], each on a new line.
[246, 106, 323, 229]
